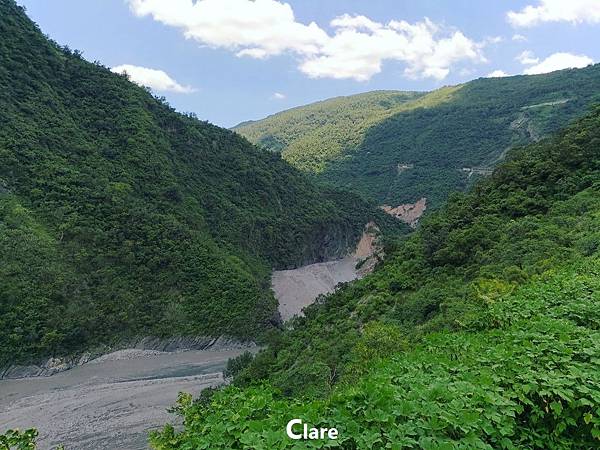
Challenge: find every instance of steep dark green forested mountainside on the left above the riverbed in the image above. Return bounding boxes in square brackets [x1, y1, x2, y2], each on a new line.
[0, 0, 394, 367]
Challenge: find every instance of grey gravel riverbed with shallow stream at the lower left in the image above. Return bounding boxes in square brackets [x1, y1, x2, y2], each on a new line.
[0, 349, 245, 450]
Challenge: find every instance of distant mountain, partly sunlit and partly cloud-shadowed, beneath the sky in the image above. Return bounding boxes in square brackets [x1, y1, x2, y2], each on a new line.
[234, 65, 600, 208]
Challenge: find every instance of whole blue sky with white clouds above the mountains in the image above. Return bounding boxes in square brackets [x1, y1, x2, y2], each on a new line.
[18, 0, 600, 127]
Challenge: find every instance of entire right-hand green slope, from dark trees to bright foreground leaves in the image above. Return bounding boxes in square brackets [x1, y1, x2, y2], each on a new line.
[153, 104, 600, 450]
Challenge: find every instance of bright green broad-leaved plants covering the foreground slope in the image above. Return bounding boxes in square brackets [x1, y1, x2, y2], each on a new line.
[152, 259, 600, 450]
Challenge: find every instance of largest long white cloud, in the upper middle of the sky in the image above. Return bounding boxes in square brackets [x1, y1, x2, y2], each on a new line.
[127, 0, 482, 81]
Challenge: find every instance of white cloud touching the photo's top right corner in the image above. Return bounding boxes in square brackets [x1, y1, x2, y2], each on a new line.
[507, 0, 600, 27]
